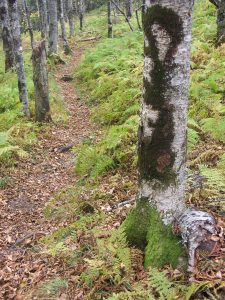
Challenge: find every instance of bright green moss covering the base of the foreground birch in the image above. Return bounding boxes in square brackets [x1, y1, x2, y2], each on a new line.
[122, 200, 184, 267]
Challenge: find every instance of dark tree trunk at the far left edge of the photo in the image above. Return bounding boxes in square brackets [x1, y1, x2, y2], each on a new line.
[0, 0, 14, 72]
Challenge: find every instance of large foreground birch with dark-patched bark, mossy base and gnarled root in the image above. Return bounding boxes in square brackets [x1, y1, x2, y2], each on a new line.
[124, 0, 215, 271]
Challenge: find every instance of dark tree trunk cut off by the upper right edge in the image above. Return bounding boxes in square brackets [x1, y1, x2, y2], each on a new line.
[217, 0, 225, 45]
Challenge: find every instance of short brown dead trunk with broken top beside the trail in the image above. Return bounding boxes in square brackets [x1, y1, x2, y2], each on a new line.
[32, 40, 51, 122]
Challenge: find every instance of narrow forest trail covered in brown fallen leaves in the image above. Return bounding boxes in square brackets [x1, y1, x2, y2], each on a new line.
[0, 44, 90, 299]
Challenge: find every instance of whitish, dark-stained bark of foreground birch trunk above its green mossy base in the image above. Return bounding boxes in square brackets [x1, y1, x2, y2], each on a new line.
[139, 0, 193, 224]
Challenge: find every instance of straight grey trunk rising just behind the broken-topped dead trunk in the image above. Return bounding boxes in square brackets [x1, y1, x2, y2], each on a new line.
[48, 0, 58, 55]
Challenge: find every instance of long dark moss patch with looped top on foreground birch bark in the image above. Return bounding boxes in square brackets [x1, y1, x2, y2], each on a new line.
[139, 5, 183, 182]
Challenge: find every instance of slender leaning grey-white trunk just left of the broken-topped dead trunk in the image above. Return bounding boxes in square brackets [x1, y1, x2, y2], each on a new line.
[8, 0, 30, 117]
